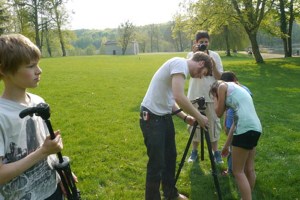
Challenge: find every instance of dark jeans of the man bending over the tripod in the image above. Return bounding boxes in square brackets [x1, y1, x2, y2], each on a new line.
[140, 107, 178, 200]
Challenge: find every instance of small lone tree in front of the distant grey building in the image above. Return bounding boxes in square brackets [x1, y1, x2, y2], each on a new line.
[118, 20, 135, 55]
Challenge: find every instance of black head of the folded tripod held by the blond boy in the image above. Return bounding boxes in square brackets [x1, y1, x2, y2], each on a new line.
[19, 103, 50, 120]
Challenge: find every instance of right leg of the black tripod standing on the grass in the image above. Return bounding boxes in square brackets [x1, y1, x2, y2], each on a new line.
[205, 131, 222, 200]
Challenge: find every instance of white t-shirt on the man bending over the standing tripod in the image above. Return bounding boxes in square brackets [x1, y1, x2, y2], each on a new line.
[141, 57, 189, 115]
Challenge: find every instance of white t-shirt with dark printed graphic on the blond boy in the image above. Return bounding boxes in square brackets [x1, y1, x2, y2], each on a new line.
[0, 93, 58, 200]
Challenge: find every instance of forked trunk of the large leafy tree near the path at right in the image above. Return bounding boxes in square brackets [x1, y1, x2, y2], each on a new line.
[231, 0, 274, 63]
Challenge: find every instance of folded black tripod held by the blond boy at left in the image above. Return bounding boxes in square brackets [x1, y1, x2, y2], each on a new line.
[19, 103, 81, 200]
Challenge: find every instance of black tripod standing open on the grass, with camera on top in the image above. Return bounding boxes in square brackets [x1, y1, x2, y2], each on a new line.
[170, 97, 222, 200]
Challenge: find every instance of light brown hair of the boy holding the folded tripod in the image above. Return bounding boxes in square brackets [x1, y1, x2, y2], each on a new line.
[0, 34, 41, 80]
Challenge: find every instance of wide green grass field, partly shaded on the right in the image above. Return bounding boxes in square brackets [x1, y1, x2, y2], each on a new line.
[1, 53, 300, 200]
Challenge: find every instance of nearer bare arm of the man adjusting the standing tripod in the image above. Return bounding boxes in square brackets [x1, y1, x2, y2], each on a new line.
[172, 74, 208, 128]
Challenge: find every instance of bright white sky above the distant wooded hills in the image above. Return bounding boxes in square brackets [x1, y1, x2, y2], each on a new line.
[67, 0, 182, 30]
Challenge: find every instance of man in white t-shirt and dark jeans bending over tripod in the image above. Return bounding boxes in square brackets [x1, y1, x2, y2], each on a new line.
[140, 52, 214, 200]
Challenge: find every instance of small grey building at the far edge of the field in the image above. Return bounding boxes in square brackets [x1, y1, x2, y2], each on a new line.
[104, 41, 139, 55]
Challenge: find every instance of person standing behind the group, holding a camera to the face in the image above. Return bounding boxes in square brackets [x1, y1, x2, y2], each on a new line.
[187, 31, 223, 164]
